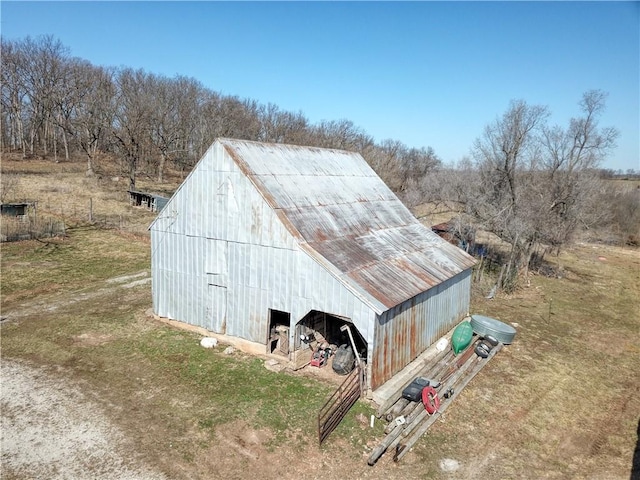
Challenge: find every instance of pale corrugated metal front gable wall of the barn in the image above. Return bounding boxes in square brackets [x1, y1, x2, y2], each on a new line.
[151, 141, 375, 343]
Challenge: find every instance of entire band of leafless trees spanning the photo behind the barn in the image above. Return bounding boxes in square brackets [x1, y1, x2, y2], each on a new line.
[0, 36, 640, 288]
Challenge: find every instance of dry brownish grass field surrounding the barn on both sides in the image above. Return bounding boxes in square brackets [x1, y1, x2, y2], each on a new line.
[0, 156, 640, 480]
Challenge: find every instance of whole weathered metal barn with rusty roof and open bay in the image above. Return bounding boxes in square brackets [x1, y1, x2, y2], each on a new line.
[150, 139, 475, 398]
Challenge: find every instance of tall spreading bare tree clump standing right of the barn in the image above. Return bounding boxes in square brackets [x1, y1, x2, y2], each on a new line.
[465, 90, 617, 288]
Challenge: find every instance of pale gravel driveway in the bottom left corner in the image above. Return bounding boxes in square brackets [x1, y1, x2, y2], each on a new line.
[0, 360, 165, 480]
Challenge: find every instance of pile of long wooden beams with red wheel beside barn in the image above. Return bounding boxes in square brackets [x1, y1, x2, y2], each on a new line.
[367, 333, 504, 466]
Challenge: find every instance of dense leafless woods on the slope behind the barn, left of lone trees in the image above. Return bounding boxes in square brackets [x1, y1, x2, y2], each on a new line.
[0, 36, 441, 198]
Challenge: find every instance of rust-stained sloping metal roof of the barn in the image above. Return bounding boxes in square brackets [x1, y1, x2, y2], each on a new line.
[219, 139, 475, 313]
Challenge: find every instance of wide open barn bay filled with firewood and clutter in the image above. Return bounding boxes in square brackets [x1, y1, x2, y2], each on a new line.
[291, 310, 367, 374]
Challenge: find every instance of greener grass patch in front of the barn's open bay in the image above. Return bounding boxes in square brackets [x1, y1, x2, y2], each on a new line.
[132, 328, 340, 438]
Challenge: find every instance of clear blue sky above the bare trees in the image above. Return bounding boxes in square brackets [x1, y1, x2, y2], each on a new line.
[0, 0, 640, 170]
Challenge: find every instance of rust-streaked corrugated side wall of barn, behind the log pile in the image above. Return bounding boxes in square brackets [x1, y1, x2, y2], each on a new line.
[371, 270, 471, 389]
